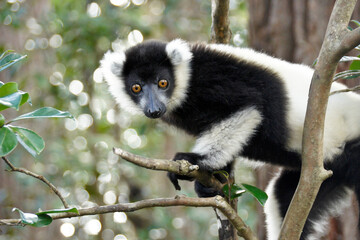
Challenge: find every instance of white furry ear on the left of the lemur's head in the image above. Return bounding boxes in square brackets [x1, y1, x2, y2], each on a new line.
[100, 51, 125, 76]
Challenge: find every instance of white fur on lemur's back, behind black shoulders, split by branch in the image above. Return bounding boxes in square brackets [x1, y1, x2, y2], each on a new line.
[210, 44, 360, 160]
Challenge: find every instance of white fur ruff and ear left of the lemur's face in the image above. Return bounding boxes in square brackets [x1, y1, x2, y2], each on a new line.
[100, 51, 142, 114]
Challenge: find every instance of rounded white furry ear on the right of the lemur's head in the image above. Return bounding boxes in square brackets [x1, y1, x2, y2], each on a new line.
[166, 39, 192, 65]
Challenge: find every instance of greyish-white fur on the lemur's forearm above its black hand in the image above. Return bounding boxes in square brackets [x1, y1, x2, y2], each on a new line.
[192, 107, 262, 169]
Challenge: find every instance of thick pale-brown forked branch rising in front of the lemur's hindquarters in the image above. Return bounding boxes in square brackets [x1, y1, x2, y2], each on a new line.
[279, 0, 360, 239]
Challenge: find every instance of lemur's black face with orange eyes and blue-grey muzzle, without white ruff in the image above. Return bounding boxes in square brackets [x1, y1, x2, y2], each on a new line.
[121, 43, 174, 118]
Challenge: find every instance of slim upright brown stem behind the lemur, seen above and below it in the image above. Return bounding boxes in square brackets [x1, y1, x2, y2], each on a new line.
[211, 0, 237, 240]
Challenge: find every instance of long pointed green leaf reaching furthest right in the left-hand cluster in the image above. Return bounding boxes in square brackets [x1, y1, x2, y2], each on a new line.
[10, 107, 74, 122]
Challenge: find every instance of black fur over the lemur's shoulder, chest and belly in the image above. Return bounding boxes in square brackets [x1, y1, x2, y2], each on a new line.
[164, 44, 300, 167]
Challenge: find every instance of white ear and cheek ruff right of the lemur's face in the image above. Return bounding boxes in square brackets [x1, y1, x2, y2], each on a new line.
[166, 39, 193, 111]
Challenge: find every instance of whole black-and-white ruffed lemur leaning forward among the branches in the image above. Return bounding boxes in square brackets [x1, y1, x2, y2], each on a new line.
[102, 40, 360, 239]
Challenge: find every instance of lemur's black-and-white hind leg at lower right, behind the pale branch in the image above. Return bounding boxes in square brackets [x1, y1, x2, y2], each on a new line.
[264, 170, 350, 240]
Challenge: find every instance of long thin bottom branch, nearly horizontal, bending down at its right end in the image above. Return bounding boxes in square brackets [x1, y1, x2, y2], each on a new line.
[0, 196, 256, 240]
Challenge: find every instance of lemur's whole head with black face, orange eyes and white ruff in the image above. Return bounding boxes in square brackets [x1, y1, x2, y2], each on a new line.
[101, 39, 192, 118]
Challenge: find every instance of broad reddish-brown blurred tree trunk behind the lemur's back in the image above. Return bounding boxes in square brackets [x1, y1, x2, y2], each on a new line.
[248, 0, 360, 239]
